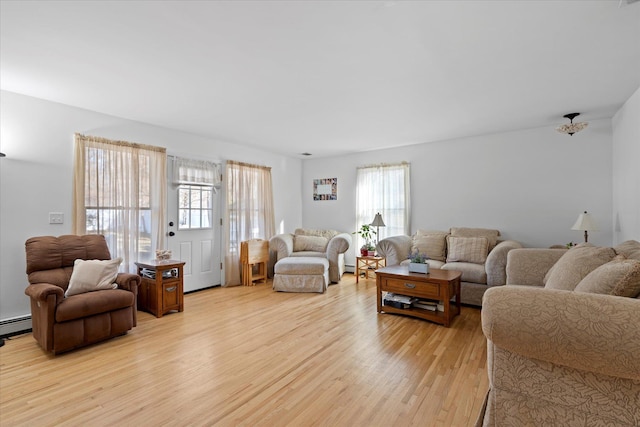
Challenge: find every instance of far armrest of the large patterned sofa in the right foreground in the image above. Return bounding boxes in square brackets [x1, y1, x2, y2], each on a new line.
[506, 248, 567, 286]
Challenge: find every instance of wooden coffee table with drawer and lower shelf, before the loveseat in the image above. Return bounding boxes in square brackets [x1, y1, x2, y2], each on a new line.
[376, 265, 462, 327]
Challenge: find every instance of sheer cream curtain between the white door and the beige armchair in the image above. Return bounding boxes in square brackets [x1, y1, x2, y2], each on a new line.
[223, 160, 276, 286]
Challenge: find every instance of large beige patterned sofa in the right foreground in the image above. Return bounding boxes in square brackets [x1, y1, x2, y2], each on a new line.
[476, 241, 640, 426]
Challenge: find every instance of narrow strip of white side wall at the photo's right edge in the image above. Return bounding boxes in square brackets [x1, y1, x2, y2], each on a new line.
[613, 88, 640, 244]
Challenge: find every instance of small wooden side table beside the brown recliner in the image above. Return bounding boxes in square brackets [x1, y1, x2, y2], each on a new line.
[136, 259, 185, 317]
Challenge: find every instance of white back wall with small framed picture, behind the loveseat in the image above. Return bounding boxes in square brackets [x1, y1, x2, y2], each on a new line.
[302, 120, 612, 264]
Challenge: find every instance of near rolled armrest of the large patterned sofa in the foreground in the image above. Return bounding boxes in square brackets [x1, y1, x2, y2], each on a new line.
[482, 286, 640, 380]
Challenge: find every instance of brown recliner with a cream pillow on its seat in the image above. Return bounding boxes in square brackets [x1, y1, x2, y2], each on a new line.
[25, 235, 140, 353]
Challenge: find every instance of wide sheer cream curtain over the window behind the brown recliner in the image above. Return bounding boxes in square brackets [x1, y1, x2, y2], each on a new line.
[72, 134, 167, 273]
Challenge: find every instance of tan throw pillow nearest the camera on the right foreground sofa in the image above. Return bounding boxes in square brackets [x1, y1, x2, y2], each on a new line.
[575, 255, 640, 298]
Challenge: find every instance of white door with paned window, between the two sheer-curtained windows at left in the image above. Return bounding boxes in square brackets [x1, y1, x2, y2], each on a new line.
[167, 162, 222, 292]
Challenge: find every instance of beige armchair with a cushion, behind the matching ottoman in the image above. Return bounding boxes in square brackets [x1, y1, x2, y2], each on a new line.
[269, 228, 351, 283]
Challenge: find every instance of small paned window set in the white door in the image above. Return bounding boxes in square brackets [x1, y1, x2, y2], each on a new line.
[178, 185, 213, 230]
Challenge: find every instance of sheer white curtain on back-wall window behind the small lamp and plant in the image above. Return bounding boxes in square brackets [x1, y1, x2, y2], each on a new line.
[353, 162, 411, 250]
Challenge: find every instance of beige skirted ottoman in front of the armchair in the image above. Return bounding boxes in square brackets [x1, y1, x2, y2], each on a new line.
[273, 257, 329, 293]
